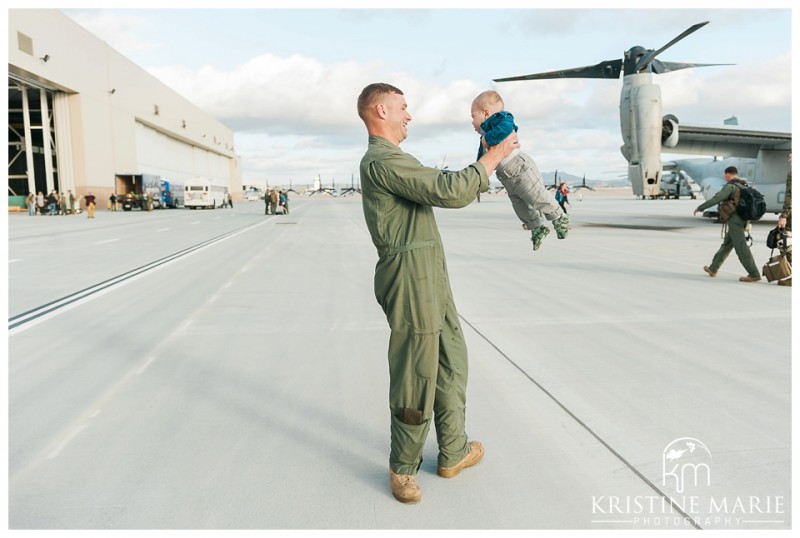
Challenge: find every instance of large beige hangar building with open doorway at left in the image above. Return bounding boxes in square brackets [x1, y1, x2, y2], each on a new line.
[8, 9, 242, 207]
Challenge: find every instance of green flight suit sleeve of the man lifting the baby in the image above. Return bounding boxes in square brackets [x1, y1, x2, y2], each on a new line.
[368, 152, 489, 208]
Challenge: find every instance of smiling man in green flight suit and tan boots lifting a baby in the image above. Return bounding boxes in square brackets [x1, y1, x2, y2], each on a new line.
[358, 83, 519, 503]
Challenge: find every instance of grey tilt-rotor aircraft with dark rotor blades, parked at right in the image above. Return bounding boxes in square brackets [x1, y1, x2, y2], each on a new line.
[494, 21, 792, 213]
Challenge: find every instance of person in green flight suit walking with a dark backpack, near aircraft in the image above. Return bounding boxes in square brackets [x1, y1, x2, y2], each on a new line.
[694, 166, 761, 282]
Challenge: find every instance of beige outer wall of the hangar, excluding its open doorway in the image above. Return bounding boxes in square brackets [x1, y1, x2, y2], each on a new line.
[8, 9, 241, 203]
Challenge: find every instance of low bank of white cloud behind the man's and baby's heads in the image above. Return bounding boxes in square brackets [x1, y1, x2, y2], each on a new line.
[142, 42, 791, 183]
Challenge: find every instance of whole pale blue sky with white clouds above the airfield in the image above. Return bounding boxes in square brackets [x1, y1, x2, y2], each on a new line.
[50, 1, 792, 186]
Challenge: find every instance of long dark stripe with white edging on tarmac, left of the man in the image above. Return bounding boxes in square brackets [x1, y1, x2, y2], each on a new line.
[8, 222, 263, 331]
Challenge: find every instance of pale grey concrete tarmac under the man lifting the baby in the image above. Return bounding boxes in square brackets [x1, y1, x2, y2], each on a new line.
[8, 191, 792, 530]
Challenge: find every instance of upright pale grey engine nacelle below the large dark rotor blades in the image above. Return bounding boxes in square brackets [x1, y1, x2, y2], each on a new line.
[619, 73, 663, 197]
